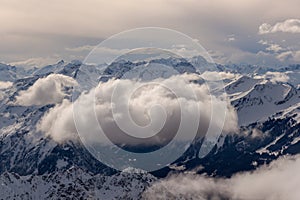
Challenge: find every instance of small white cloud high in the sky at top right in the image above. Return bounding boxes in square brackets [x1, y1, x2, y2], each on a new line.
[258, 19, 300, 34]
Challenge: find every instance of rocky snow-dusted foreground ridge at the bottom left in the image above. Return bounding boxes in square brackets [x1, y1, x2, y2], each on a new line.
[0, 167, 156, 200]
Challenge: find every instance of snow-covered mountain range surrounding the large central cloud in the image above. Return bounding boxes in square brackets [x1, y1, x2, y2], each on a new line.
[0, 55, 300, 199]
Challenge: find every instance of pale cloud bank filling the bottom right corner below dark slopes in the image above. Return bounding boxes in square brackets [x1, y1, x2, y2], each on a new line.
[144, 156, 300, 200]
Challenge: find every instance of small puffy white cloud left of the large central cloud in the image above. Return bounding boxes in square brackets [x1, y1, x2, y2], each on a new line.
[15, 74, 76, 106]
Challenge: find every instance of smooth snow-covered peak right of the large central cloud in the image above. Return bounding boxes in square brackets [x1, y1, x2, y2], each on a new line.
[229, 79, 300, 125]
